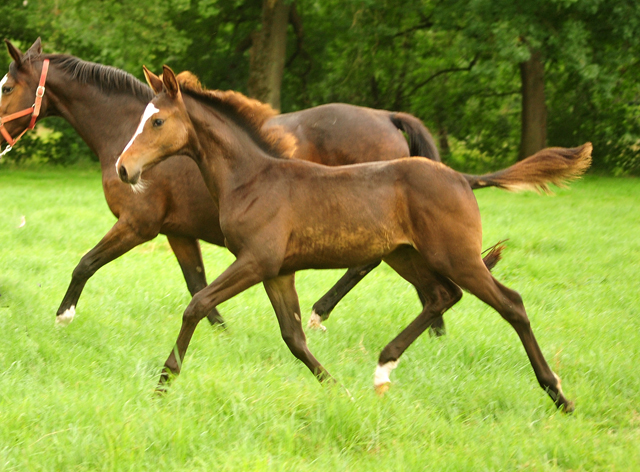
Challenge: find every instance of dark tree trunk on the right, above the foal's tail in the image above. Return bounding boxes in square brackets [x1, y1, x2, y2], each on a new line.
[518, 51, 547, 159]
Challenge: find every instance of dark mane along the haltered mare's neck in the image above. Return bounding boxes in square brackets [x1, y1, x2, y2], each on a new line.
[41, 54, 153, 101]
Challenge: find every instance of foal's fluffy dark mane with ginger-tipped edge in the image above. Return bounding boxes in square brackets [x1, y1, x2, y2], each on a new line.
[176, 71, 297, 158]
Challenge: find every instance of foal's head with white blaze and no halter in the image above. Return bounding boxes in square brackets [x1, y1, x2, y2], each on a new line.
[116, 66, 195, 185]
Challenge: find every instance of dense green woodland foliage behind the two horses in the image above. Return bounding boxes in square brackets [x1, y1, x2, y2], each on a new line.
[0, 0, 640, 170]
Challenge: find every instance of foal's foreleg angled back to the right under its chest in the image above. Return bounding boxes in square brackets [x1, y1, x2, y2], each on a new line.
[263, 274, 332, 382]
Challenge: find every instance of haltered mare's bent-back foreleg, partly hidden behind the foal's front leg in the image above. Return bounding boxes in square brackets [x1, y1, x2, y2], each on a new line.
[167, 236, 224, 326]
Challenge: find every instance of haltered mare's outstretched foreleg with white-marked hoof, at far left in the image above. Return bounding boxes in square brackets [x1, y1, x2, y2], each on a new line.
[56, 220, 158, 326]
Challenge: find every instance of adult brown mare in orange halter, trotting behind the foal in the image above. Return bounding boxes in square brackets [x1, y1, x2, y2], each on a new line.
[0, 38, 450, 326]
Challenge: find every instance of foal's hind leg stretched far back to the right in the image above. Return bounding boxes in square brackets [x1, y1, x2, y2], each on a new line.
[444, 264, 574, 413]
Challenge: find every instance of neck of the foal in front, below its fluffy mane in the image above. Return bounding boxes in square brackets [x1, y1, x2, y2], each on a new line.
[185, 97, 276, 201]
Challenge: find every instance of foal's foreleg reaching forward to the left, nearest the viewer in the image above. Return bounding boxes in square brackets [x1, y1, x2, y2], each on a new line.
[157, 259, 263, 392]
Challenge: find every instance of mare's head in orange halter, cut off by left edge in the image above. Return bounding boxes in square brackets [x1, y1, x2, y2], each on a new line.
[0, 38, 46, 143]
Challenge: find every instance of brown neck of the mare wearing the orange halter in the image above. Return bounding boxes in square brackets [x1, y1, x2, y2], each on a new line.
[46, 66, 151, 169]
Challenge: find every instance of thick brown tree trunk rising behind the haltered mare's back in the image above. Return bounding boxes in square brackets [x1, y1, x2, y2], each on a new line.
[247, 0, 291, 110]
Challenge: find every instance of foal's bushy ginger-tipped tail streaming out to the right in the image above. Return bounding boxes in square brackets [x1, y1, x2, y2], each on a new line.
[462, 143, 593, 193]
